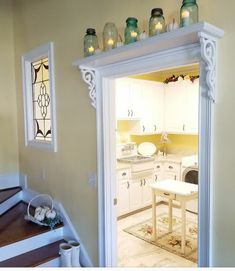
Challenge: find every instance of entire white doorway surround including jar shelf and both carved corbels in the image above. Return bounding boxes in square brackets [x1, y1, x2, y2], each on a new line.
[73, 22, 224, 267]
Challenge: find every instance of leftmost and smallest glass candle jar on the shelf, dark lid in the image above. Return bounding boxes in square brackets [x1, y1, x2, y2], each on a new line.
[84, 28, 99, 57]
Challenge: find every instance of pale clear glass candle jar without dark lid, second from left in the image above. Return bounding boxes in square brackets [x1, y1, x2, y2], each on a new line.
[103, 23, 118, 51]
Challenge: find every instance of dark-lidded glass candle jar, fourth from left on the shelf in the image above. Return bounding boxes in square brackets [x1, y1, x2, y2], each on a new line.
[149, 8, 165, 37]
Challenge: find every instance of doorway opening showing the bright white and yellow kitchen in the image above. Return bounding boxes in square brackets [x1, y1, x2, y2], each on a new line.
[114, 64, 200, 267]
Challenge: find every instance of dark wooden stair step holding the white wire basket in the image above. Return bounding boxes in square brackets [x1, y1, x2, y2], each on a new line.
[0, 201, 63, 247]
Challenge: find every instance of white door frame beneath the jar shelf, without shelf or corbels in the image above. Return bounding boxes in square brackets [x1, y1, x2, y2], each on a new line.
[96, 44, 213, 267]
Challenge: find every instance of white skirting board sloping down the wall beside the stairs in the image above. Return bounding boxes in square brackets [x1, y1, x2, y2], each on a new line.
[22, 189, 93, 267]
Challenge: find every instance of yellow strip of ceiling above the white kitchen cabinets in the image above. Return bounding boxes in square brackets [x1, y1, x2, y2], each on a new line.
[130, 63, 199, 82]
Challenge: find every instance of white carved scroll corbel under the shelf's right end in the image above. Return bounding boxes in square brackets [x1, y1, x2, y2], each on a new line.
[199, 33, 216, 103]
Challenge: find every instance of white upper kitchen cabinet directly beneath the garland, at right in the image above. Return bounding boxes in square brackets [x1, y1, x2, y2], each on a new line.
[165, 79, 199, 134]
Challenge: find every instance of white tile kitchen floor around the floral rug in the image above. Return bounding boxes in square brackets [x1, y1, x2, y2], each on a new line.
[118, 204, 197, 267]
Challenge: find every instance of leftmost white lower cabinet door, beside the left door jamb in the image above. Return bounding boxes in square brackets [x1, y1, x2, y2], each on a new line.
[117, 180, 130, 216]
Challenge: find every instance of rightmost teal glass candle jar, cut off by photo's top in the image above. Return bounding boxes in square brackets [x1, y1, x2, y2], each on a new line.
[180, 0, 198, 27]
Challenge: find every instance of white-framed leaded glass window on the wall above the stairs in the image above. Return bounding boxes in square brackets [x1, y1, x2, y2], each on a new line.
[22, 43, 57, 152]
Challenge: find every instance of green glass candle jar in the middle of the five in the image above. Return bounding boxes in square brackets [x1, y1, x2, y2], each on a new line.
[125, 17, 140, 44]
